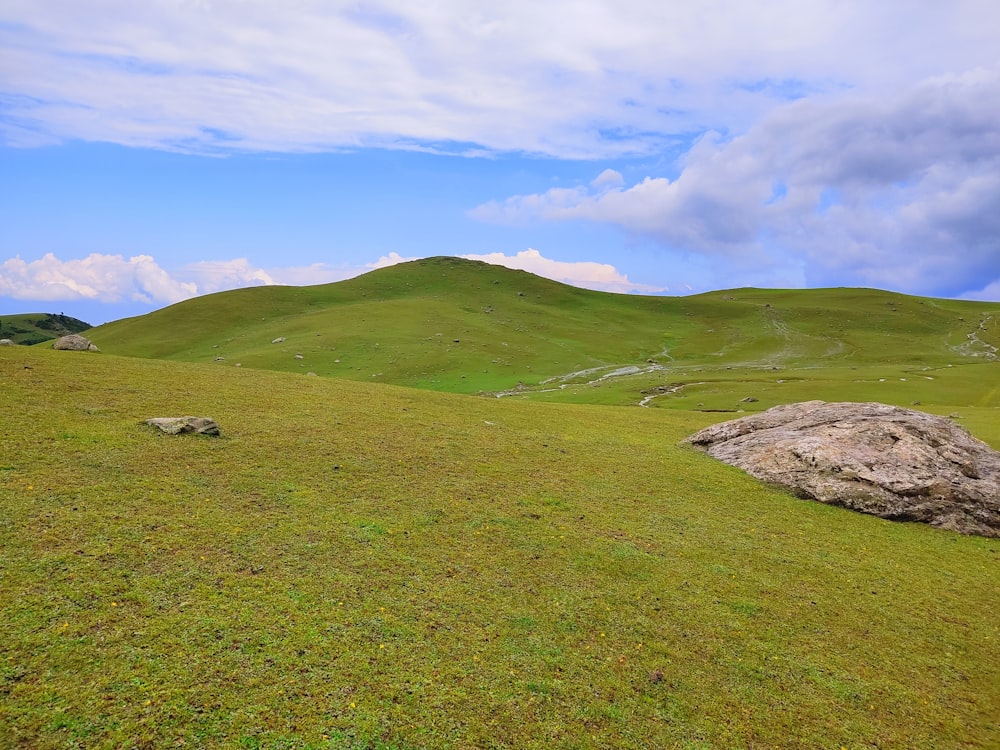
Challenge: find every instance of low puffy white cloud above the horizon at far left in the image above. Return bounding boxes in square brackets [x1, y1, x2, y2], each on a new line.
[0, 253, 198, 304]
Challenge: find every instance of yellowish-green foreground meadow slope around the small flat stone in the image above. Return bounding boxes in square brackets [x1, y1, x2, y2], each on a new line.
[0, 348, 1000, 750]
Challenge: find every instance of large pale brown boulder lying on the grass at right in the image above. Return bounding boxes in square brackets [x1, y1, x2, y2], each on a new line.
[686, 401, 1000, 537]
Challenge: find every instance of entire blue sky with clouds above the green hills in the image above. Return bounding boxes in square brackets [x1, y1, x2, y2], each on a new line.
[0, 0, 1000, 324]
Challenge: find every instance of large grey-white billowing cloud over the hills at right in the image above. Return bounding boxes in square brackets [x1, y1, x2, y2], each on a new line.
[470, 68, 1000, 296]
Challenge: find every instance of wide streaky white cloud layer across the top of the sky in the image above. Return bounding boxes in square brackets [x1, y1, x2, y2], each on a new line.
[0, 0, 1000, 158]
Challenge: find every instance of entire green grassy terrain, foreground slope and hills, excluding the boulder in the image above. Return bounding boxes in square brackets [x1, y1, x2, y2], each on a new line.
[9, 258, 1000, 750]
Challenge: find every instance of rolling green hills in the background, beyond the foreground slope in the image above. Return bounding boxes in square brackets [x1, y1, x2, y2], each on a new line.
[92, 258, 1000, 402]
